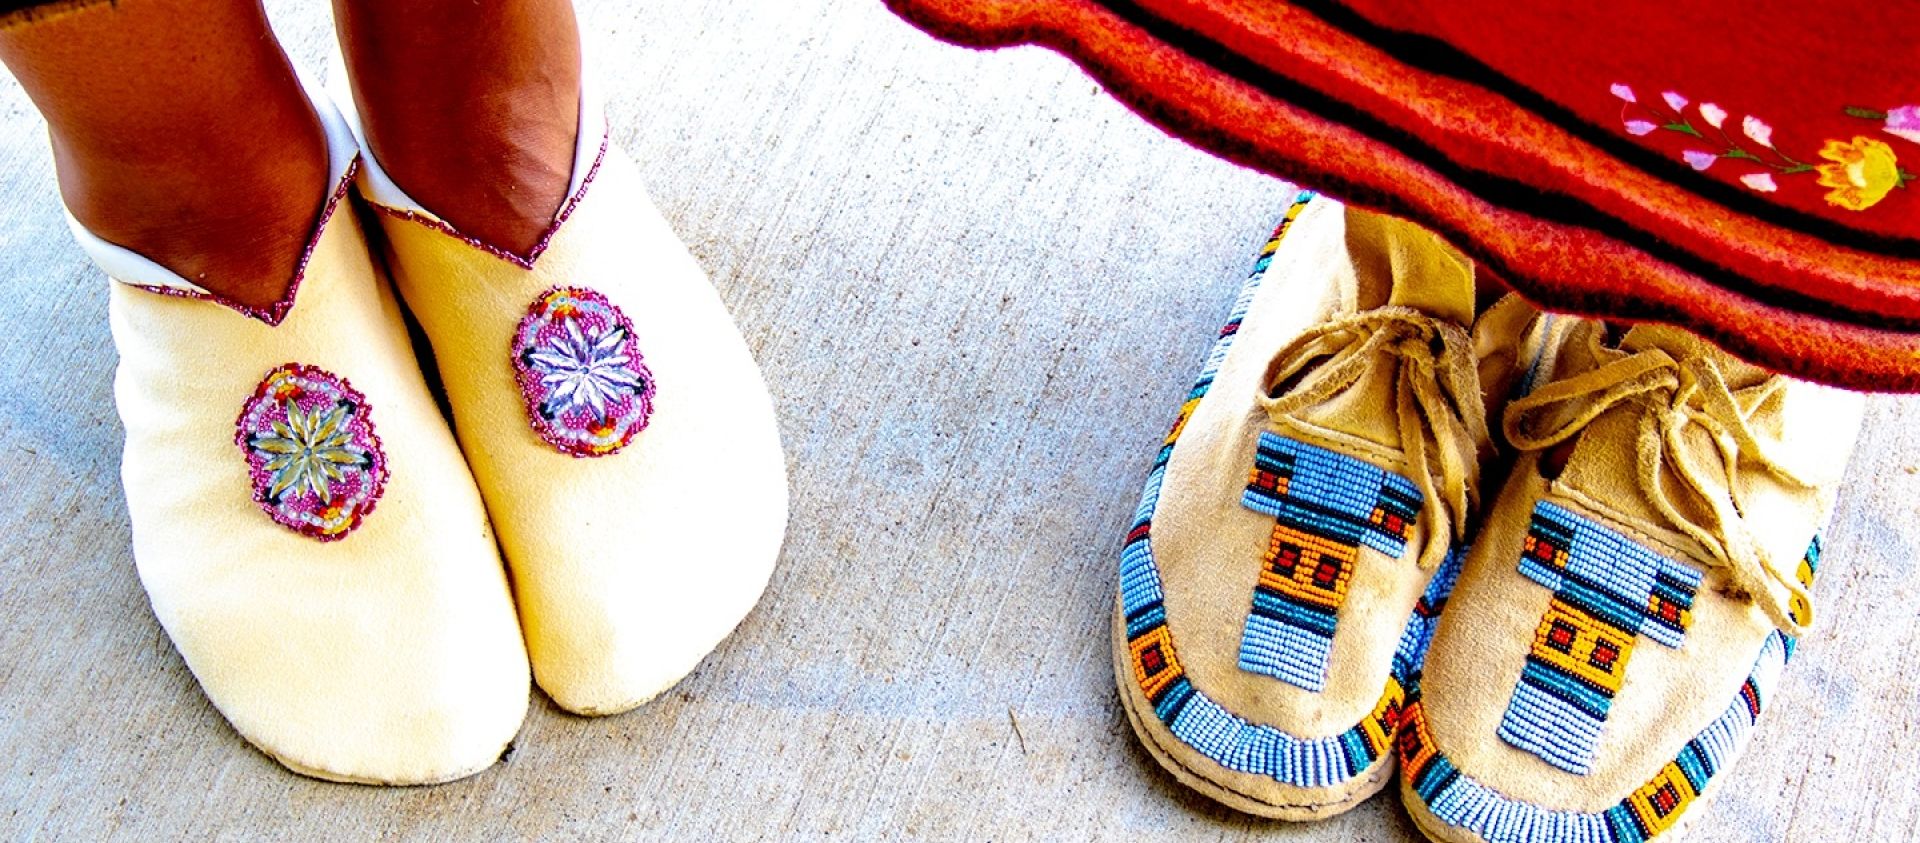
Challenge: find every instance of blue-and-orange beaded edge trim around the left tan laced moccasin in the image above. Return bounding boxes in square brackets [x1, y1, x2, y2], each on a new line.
[1119, 190, 1465, 787]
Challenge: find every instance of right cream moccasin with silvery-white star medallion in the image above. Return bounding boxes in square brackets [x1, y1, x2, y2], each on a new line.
[340, 79, 787, 714]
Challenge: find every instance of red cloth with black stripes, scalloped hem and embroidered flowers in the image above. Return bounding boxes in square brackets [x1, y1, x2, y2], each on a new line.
[887, 0, 1920, 392]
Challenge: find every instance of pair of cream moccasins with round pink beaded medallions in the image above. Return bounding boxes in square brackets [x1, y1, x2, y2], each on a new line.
[75, 79, 787, 783]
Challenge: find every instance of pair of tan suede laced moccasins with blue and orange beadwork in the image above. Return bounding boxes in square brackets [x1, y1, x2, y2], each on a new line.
[1114, 196, 1862, 843]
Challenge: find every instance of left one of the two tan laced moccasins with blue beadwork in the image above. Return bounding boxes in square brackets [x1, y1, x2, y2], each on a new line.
[1114, 196, 1542, 820]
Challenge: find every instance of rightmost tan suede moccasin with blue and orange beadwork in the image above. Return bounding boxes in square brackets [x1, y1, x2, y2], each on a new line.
[1398, 323, 1862, 843]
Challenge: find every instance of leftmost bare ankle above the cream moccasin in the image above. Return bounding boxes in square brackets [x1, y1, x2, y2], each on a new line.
[0, 0, 332, 305]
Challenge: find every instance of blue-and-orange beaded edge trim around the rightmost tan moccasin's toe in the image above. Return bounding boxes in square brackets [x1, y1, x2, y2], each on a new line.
[1394, 536, 1820, 843]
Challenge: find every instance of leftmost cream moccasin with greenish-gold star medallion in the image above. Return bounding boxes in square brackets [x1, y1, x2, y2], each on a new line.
[73, 84, 528, 783]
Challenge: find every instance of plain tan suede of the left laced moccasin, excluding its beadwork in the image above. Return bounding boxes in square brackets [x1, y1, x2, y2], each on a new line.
[1116, 198, 1530, 818]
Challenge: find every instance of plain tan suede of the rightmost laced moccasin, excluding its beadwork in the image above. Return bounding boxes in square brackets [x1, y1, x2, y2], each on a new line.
[1409, 323, 1862, 841]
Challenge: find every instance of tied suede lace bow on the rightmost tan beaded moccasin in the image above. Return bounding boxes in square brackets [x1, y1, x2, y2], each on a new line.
[1505, 349, 1812, 636]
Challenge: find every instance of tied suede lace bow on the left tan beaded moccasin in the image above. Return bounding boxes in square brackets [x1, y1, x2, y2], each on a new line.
[1261, 307, 1492, 568]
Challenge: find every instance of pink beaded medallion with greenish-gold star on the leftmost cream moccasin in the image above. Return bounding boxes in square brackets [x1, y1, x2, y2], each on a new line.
[234, 363, 388, 542]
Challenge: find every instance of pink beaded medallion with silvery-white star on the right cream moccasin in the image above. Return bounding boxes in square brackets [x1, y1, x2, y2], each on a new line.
[513, 286, 653, 457]
